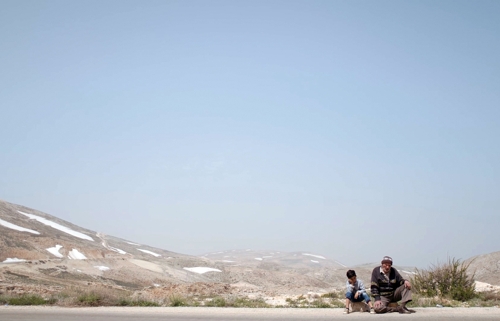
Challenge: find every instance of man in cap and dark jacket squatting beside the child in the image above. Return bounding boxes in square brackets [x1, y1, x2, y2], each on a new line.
[370, 256, 415, 313]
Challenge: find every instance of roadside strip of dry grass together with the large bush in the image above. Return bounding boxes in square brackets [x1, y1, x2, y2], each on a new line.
[0, 259, 500, 308]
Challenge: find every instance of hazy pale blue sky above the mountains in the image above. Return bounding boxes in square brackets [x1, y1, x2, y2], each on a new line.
[0, 0, 500, 267]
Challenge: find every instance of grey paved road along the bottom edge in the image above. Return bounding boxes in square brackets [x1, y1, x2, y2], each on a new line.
[0, 306, 500, 321]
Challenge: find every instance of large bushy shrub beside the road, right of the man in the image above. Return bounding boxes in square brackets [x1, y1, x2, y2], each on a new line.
[411, 258, 477, 301]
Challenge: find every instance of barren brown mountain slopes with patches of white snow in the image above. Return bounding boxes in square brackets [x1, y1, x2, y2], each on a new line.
[0, 200, 500, 297]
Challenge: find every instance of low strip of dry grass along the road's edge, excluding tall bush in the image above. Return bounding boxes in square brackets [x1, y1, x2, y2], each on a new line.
[0, 278, 500, 308]
